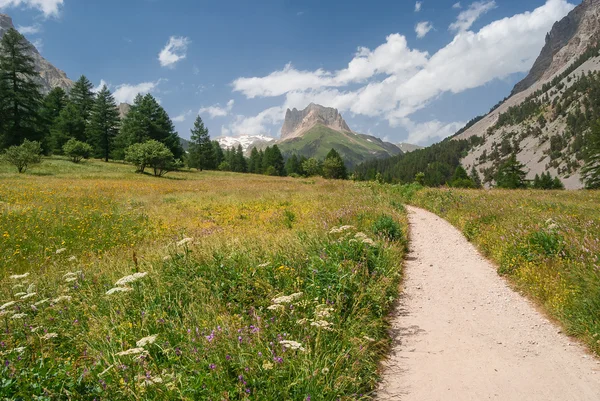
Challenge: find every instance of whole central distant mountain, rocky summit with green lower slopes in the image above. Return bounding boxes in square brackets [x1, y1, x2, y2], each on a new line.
[277, 103, 402, 167]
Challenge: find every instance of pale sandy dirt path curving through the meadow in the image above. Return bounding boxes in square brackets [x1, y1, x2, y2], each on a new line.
[377, 207, 600, 401]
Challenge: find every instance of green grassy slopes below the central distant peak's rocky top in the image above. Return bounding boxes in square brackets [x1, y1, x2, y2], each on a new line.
[278, 125, 400, 166]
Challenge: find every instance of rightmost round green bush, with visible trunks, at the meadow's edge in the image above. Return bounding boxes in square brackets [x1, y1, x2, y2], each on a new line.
[125, 140, 175, 177]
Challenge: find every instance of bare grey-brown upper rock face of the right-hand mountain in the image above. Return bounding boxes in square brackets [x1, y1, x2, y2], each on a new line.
[511, 0, 600, 95]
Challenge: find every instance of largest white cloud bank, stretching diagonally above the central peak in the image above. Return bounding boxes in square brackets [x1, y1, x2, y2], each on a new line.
[229, 0, 574, 142]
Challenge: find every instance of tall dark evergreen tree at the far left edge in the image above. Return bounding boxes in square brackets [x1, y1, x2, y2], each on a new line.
[0, 28, 42, 148]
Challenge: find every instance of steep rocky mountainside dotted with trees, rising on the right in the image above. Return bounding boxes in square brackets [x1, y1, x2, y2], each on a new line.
[455, 0, 600, 189]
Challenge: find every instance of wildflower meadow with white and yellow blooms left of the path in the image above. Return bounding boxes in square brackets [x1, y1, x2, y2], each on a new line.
[0, 159, 407, 400]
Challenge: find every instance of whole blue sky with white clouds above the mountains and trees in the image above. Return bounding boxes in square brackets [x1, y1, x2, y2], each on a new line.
[0, 0, 574, 145]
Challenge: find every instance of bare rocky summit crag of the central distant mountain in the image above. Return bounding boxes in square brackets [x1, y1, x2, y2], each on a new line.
[281, 103, 352, 141]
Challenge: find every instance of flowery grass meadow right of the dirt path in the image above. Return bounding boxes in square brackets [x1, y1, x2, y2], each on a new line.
[388, 185, 600, 355]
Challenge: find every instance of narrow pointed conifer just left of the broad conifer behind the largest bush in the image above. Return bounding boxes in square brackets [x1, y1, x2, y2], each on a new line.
[88, 85, 120, 162]
